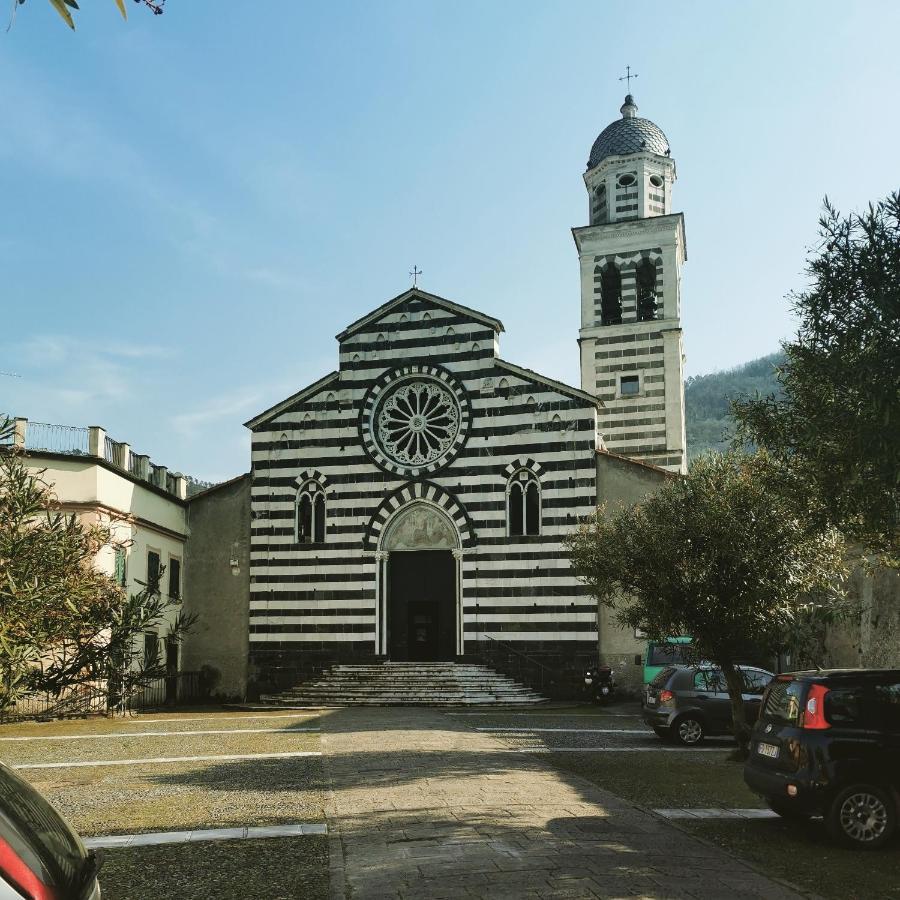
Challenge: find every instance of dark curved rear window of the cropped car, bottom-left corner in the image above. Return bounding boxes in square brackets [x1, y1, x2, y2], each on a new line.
[0, 766, 87, 888]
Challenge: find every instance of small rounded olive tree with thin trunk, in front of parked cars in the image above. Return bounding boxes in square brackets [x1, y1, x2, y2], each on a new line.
[569, 451, 845, 747]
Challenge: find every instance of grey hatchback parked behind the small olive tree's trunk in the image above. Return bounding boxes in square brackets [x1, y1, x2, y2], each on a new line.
[641, 664, 774, 746]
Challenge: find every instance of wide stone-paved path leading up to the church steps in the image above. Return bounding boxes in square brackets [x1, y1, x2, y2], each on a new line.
[322, 708, 801, 900]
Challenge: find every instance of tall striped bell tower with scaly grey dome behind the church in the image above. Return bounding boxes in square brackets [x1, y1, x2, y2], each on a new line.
[572, 94, 687, 472]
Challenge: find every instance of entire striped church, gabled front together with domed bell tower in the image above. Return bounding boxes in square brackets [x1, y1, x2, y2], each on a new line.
[188, 95, 686, 688]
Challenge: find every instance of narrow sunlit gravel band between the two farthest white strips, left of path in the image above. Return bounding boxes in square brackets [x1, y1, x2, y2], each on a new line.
[0, 723, 319, 766]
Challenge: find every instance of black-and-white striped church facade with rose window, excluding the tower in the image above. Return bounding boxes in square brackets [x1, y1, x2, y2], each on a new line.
[247, 289, 599, 680]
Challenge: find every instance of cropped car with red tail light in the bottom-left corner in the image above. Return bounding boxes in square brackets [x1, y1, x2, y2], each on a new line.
[0, 763, 100, 900]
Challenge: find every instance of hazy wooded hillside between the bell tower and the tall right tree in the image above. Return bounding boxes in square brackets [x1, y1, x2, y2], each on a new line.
[684, 350, 785, 460]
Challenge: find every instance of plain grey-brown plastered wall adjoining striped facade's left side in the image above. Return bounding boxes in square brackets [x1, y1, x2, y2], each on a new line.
[182, 475, 250, 699]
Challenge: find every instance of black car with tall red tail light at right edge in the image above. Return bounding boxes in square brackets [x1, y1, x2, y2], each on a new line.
[744, 669, 900, 850]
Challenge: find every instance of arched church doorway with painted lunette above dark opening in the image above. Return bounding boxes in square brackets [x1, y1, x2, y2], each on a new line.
[378, 500, 461, 662]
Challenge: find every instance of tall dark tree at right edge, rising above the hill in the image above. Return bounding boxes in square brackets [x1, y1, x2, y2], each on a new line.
[732, 192, 900, 566]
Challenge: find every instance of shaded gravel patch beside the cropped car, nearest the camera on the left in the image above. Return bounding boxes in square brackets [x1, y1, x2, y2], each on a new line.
[100, 837, 328, 900]
